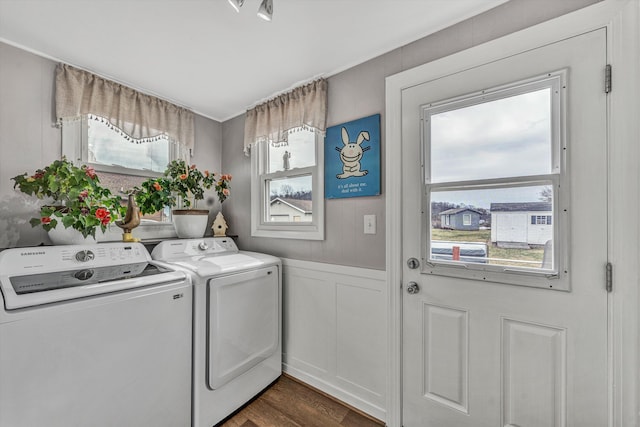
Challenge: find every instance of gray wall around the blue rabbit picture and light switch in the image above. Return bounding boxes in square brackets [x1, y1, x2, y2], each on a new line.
[222, 0, 599, 270]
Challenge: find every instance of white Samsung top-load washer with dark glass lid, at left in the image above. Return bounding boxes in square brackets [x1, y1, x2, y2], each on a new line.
[0, 243, 193, 427]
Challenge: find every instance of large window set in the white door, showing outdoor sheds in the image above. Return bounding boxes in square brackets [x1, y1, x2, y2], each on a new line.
[422, 72, 566, 286]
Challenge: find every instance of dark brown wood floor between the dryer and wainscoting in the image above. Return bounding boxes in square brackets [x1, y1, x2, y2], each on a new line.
[219, 375, 384, 427]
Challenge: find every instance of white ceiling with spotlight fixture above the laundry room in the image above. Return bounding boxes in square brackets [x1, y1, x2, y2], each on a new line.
[0, 0, 506, 121]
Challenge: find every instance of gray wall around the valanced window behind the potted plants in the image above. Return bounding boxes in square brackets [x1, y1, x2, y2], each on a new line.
[0, 42, 222, 248]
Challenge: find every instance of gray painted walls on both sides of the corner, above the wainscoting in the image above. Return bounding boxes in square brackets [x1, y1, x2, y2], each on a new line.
[0, 0, 597, 254]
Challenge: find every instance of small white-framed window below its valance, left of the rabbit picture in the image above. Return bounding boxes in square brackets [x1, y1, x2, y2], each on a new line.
[251, 129, 324, 240]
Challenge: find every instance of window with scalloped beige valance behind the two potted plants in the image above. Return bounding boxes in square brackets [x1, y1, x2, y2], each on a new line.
[55, 64, 194, 234]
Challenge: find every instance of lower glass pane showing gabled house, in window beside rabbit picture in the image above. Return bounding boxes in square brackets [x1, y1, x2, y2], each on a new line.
[266, 175, 313, 222]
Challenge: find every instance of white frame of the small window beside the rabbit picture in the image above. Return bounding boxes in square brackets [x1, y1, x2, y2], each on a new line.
[251, 131, 324, 240]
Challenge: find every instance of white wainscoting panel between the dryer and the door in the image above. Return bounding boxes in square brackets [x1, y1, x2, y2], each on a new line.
[283, 259, 387, 420]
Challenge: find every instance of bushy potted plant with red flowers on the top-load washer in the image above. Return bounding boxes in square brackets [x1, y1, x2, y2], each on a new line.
[11, 157, 123, 244]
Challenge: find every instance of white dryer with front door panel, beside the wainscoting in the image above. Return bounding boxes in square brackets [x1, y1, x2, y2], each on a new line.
[151, 237, 282, 427]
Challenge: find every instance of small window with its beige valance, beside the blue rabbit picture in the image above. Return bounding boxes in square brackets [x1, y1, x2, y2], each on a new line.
[244, 79, 327, 240]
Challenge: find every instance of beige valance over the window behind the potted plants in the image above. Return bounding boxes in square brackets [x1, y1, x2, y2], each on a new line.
[56, 64, 194, 149]
